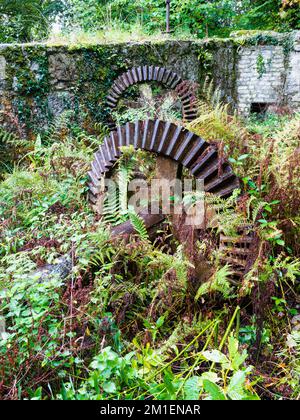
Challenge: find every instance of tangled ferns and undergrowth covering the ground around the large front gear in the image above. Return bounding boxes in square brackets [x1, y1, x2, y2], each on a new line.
[0, 86, 300, 400]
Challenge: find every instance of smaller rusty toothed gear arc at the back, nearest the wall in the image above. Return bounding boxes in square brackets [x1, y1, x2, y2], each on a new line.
[106, 65, 197, 131]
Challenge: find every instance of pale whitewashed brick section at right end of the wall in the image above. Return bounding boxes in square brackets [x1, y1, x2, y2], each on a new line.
[236, 32, 300, 115]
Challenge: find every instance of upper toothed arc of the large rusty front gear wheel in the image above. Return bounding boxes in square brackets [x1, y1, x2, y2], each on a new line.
[89, 120, 240, 204]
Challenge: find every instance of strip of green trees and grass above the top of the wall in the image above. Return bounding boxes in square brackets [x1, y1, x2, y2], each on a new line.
[0, 0, 300, 42]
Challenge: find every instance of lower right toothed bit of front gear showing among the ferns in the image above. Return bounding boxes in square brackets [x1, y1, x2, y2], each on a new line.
[219, 225, 258, 279]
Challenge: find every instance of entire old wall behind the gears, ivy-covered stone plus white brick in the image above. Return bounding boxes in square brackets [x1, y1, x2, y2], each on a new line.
[0, 32, 300, 132]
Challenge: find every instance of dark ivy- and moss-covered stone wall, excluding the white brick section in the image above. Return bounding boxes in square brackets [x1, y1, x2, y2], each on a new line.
[0, 32, 295, 133]
